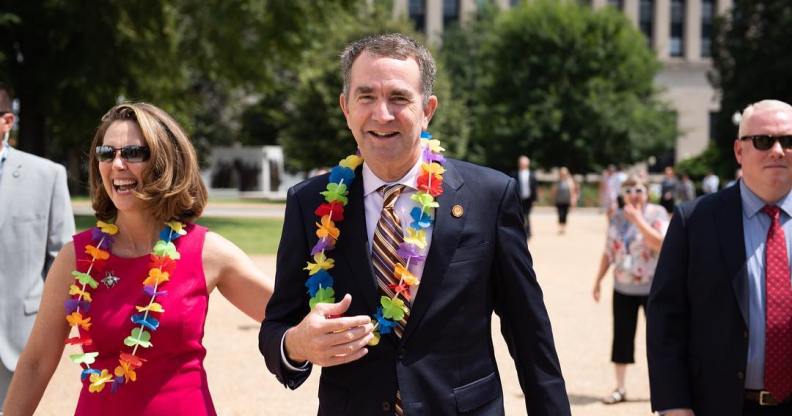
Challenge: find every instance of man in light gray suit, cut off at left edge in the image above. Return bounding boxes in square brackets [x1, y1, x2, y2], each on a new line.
[0, 84, 74, 409]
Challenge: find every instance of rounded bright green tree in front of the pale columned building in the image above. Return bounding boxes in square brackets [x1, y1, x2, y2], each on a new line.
[470, 0, 677, 172]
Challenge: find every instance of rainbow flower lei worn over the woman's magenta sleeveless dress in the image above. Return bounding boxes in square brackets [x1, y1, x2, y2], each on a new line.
[65, 221, 187, 393]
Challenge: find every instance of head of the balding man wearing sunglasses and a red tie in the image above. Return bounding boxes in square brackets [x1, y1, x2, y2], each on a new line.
[734, 103, 792, 203]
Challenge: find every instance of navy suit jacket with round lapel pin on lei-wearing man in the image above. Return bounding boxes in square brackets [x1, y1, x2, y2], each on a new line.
[259, 160, 570, 416]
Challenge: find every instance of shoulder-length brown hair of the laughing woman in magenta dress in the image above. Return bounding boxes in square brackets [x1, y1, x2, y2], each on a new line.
[88, 103, 207, 222]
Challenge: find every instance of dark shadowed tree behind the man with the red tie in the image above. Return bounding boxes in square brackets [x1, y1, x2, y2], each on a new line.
[710, 0, 792, 177]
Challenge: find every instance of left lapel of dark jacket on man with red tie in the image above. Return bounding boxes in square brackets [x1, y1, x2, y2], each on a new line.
[715, 185, 748, 325]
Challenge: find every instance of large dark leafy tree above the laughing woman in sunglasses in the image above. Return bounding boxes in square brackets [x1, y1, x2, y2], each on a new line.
[0, 0, 362, 184]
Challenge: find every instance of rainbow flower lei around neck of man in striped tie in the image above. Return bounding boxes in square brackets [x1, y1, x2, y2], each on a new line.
[303, 132, 445, 346]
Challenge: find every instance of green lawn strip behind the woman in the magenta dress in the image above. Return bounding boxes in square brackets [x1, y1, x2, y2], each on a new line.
[74, 215, 283, 255]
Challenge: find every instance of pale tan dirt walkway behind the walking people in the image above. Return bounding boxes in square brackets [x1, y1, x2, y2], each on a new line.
[36, 210, 650, 416]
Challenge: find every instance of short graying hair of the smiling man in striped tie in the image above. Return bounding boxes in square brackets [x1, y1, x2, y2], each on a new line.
[341, 33, 437, 104]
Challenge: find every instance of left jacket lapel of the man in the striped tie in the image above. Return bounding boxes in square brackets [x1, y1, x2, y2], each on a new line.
[337, 169, 379, 314]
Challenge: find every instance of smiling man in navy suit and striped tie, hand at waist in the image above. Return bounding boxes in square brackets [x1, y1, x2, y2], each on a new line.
[259, 34, 570, 416]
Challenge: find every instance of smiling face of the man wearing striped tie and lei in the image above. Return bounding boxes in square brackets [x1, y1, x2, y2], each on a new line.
[340, 52, 437, 181]
